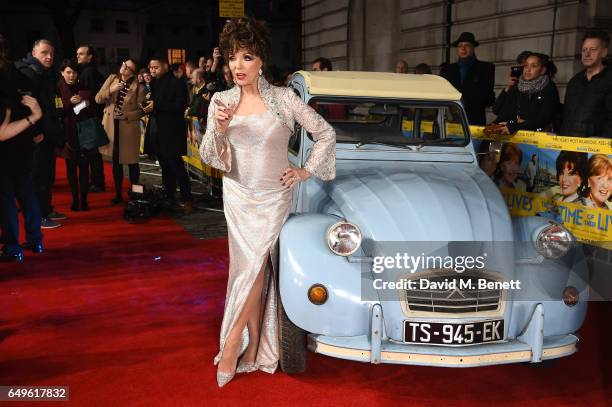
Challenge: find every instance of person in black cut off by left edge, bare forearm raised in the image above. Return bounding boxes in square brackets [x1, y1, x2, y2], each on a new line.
[0, 35, 44, 262]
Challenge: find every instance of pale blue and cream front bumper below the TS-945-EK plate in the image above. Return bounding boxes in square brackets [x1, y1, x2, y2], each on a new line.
[308, 305, 578, 367]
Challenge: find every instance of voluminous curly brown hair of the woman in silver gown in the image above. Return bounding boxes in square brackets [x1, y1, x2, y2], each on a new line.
[219, 17, 270, 65]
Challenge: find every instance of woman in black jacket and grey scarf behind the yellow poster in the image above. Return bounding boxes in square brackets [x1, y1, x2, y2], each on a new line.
[493, 53, 559, 134]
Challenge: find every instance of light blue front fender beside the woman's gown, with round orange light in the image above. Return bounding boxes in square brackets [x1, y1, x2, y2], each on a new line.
[278, 213, 370, 336]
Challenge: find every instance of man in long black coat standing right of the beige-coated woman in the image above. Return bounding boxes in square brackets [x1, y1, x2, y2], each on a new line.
[143, 58, 192, 213]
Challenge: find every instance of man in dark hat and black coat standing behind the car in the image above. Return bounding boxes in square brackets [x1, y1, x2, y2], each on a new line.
[441, 32, 495, 126]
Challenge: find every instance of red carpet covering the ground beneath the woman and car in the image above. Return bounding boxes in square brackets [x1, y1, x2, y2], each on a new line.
[0, 161, 612, 407]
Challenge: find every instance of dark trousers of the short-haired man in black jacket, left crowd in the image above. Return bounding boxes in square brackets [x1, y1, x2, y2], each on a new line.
[32, 141, 55, 218]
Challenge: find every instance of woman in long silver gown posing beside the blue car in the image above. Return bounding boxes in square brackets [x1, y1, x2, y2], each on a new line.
[200, 18, 336, 386]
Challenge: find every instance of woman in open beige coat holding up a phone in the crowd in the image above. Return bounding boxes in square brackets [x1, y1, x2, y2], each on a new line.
[96, 59, 145, 204]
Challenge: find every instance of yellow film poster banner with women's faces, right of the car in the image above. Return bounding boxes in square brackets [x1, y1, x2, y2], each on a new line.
[472, 128, 612, 249]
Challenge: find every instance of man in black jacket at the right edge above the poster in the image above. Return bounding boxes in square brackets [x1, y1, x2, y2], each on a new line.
[561, 31, 612, 138]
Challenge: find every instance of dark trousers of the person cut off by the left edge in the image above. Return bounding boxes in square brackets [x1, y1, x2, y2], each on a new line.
[0, 173, 42, 254]
